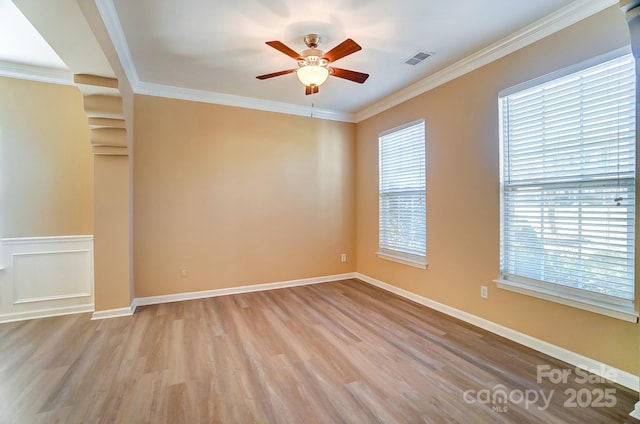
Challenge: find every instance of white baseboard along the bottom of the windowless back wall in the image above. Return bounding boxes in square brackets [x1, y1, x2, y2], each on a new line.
[132, 272, 356, 311]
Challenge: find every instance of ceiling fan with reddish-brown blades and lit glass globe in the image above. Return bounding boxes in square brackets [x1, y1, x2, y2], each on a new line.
[256, 34, 369, 95]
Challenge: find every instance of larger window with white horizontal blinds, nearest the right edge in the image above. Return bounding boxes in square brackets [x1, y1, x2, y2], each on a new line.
[498, 49, 637, 321]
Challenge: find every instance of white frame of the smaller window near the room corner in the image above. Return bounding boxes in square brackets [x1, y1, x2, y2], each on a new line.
[377, 119, 427, 269]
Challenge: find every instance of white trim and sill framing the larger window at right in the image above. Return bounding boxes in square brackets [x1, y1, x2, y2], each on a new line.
[494, 46, 640, 323]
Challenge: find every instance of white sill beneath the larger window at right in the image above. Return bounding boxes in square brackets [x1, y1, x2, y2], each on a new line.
[494, 279, 638, 323]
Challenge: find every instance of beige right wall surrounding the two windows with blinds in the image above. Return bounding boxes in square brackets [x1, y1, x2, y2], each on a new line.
[356, 7, 640, 375]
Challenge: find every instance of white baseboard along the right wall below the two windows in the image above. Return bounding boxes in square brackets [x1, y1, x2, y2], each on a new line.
[355, 273, 640, 392]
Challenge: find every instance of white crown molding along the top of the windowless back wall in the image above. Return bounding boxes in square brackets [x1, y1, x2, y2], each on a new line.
[134, 81, 352, 122]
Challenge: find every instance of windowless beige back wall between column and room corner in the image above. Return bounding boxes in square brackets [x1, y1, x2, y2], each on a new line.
[133, 95, 355, 297]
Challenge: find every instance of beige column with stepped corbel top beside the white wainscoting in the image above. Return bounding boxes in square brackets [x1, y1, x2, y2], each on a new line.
[74, 74, 133, 317]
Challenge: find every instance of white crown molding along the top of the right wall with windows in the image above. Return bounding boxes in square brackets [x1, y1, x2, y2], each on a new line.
[354, 0, 618, 122]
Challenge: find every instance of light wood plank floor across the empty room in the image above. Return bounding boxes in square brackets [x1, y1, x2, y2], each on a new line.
[0, 280, 639, 424]
